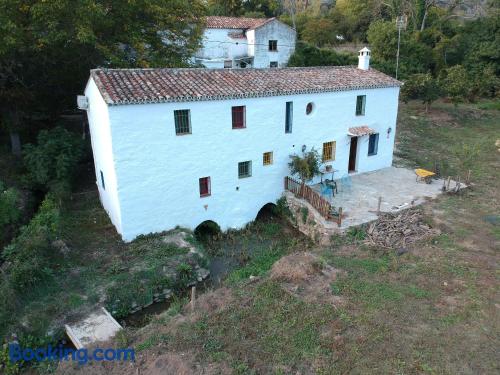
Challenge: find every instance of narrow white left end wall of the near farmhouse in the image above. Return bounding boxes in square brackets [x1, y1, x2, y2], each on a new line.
[85, 78, 122, 233]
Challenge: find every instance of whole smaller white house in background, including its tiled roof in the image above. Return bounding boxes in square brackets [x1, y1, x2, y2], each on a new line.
[195, 16, 296, 68]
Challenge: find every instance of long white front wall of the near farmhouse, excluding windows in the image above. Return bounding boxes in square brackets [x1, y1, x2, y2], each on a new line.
[103, 88, 399, 240]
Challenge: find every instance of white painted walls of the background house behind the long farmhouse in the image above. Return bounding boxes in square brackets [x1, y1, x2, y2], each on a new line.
[194, 19, 296, 68]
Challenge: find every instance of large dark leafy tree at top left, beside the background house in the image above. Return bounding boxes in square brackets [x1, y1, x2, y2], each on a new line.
[0, 0, 205, 154]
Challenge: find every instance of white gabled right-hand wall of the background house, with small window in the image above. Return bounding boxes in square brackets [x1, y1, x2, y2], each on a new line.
[254, 20, 296, 68]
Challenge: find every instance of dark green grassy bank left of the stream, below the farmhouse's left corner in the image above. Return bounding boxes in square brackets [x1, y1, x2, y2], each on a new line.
[0, 192, 206, 342]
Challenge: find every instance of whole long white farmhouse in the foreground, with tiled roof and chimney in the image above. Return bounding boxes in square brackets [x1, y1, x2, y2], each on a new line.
[85, 50, 400, 241]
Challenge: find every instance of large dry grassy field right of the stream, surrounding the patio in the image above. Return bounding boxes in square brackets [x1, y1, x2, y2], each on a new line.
[107, 102, 500, 374]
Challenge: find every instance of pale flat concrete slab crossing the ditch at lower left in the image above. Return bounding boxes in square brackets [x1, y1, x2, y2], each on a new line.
[65, 307, 122, 349]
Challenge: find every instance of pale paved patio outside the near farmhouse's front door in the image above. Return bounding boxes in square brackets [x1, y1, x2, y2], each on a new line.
[311, 167, 455, 230]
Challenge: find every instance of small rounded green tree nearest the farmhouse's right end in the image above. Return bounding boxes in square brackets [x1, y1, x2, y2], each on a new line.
[401, 73, 441, 112]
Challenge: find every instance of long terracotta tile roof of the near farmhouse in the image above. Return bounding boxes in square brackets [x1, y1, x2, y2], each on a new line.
[90, 66, 401, 105]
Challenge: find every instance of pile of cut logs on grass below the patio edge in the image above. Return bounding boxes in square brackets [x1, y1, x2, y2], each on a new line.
[365, 209, 439, 250]
